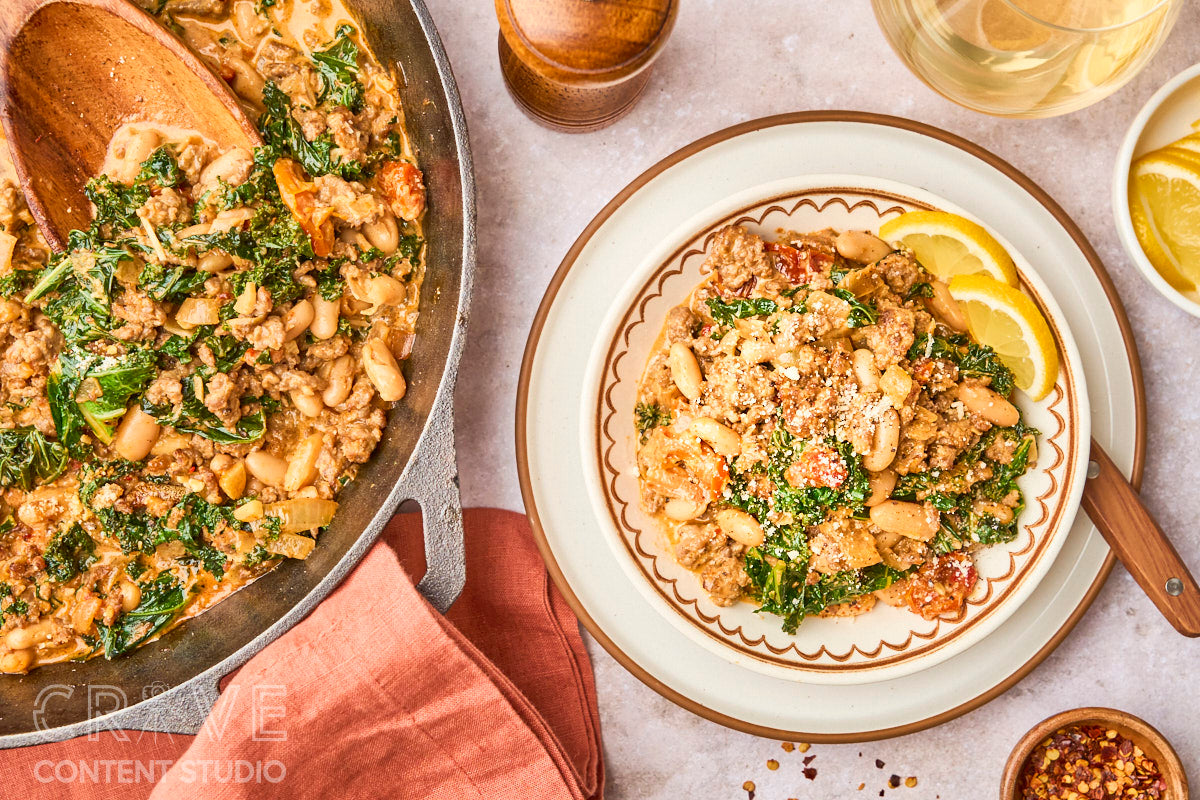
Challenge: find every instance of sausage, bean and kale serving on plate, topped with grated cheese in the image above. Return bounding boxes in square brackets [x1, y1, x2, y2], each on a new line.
[634, 227, 1037, 632]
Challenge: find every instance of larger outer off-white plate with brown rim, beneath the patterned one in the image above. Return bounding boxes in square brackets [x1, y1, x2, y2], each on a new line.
[516, 112, 1145, 741]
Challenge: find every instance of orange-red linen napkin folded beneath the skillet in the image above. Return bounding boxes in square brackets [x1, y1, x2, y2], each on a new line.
[0, 509, 604, 800]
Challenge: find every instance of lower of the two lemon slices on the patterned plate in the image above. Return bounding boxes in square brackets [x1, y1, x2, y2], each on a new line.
[949, 275, 1058, 401]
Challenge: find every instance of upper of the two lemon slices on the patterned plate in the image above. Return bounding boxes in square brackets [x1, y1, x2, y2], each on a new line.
[880, 211, 1016, 287]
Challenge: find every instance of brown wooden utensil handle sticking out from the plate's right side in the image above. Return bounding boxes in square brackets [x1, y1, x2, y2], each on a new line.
[1084, 439, 1200, 637]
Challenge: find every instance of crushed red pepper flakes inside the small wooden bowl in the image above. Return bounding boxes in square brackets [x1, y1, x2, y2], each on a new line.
[1020, 724, 1166, 800]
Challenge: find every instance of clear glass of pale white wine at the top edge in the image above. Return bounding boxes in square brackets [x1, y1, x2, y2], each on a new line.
[871, 0, 1184, 116]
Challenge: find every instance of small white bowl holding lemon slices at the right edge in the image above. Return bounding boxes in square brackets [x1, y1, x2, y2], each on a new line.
[1112, 64, 1200, 317]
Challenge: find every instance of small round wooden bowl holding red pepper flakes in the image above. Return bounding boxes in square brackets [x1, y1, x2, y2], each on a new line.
[1000, 708, 1188, 800]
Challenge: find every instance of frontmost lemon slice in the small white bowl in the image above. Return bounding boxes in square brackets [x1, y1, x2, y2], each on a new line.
[1129, 150, 1200, 296]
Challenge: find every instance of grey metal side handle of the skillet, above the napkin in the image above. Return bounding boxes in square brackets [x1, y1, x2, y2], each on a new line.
[403, 379, 467, 614]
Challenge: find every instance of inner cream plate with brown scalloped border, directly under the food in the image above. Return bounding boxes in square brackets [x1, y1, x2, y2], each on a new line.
[580, 175, 1090, 684]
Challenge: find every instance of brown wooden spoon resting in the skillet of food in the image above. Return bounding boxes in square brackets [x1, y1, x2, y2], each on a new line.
[0, 0, 259, 251]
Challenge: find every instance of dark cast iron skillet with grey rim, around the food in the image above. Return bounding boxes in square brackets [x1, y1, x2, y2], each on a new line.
[0, 0, 475, 747]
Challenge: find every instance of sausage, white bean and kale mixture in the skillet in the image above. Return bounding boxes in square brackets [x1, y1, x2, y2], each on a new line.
[0, 0, 425, 673]
